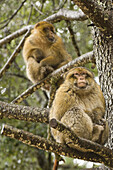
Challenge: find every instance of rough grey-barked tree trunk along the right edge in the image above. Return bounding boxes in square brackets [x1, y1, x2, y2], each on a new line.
[94, 0, 113, 167]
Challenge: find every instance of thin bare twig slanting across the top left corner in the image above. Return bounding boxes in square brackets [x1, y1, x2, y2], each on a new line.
[0, 0, 26, 29]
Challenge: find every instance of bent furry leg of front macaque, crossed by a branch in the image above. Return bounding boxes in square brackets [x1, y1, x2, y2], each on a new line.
[53, 107, 93, 151]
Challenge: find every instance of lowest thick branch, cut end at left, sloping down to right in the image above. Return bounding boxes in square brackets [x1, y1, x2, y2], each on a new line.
[1, 125, 113, 167]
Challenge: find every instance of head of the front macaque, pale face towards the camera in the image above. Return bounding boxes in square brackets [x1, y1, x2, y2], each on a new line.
[66, 67, 95, 94]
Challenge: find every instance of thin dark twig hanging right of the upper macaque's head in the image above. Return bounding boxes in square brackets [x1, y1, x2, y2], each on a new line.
[67, 21, 80, 57]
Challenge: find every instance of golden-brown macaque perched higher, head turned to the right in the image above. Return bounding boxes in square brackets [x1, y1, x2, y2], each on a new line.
[23, 21, 72, 83]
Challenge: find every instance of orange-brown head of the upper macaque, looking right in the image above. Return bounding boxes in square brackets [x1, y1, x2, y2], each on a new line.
[35, 21, 56, 43]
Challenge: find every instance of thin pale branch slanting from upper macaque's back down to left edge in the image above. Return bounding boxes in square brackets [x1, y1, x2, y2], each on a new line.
[0, 30, 30, 78]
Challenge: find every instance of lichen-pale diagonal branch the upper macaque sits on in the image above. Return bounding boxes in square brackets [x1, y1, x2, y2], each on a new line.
[12, 51, 95, 103]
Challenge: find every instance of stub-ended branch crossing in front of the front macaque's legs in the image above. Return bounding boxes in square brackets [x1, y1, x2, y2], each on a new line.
[50, 119, 113, 160]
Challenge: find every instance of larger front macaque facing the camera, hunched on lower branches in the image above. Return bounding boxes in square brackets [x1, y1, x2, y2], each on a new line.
[49, 67, 109, 149]
